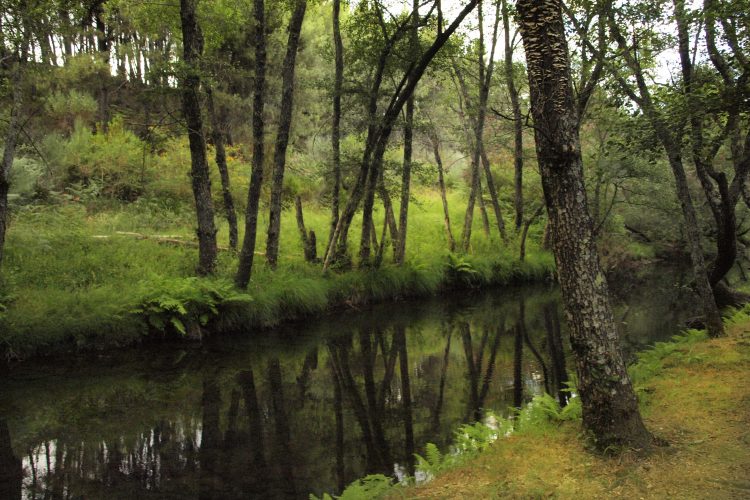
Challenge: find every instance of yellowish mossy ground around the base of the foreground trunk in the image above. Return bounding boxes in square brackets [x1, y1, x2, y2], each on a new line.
[405, 317, 750, 499]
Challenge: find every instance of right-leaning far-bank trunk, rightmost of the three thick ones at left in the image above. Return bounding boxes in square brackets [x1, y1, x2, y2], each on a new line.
[266, 0, 307, 268]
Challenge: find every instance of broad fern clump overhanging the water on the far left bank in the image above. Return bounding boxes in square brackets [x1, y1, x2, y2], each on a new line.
[134, 277, 252, 336]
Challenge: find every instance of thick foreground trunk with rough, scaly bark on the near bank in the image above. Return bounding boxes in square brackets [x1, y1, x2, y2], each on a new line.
[517, 0, 652, 450]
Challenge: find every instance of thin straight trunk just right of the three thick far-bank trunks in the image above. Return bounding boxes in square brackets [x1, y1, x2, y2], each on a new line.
[323, 0, 344, 266]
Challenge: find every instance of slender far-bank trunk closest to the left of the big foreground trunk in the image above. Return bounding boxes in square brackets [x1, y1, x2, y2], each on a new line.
[501, 0, 523, 231]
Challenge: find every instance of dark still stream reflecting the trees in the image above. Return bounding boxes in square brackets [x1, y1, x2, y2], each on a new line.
[0, 273, 692, 498]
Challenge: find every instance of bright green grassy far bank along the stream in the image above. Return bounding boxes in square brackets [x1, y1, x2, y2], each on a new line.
[0, 191, 554, 359]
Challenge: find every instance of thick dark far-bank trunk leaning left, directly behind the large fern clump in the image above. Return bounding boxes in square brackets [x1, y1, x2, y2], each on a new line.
[180, 0, 216, 275]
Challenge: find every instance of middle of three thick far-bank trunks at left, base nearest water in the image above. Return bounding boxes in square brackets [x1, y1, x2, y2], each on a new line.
[234, 0, 266, 289]
